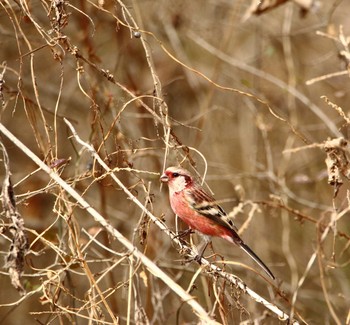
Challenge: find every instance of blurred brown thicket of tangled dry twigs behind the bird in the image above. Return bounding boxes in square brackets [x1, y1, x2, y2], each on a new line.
[0, 0, 350, 324]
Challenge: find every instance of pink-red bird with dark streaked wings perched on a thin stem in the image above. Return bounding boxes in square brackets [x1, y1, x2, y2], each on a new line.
[160, 166, 275, 280]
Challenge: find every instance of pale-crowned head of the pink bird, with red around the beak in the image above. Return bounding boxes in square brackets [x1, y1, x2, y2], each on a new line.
[160, 167, 193, 192]
